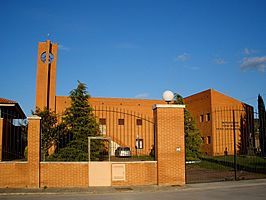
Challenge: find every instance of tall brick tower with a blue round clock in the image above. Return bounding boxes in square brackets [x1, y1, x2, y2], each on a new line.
[36, 40, 58, 111]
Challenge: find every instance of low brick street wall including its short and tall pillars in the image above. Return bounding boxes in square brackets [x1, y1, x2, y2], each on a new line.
[0, 106, 185, 188]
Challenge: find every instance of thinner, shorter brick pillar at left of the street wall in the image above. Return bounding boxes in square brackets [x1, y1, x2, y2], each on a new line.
[28, 116, 41, 188]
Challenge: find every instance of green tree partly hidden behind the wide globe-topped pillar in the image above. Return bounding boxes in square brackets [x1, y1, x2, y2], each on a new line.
[174, 93, 202, 160]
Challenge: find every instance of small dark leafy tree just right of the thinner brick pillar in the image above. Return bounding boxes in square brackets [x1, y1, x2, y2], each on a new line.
[32, 107, 59, 158]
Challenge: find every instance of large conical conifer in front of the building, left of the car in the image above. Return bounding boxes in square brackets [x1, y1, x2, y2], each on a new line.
[53, 81, 100, 161]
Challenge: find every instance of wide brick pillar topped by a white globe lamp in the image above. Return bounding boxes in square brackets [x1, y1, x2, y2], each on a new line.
[153, 104, 185, 185]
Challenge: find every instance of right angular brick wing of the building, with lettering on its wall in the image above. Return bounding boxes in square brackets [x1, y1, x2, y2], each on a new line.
[184, 89, 253, 156]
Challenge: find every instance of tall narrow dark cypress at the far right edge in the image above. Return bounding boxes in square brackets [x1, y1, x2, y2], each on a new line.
[258, 94, 266, 156]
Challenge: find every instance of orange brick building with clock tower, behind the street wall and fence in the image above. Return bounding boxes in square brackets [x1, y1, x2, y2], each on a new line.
[36, 40, 253, 155]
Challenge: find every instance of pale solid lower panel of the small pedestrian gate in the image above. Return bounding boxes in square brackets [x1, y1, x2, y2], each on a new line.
[89, 162, 111, 187]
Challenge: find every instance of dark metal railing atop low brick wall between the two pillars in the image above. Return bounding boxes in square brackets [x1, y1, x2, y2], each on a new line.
[41, 106, 155, 161]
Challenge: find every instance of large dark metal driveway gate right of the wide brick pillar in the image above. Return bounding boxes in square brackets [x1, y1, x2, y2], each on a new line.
[186, 106, 266, 183]
